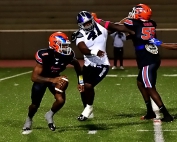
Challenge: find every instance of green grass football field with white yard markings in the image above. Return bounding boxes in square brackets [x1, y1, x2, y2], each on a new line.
[0, 67, 177, 142]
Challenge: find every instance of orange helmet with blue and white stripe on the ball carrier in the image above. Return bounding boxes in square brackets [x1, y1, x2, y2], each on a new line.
[49, 32, 71, 55]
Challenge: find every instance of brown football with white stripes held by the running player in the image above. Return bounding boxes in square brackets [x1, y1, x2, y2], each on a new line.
[55, 76, 69, 93]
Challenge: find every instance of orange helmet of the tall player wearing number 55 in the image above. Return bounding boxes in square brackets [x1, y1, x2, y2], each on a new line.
[128, 4, 152, 21]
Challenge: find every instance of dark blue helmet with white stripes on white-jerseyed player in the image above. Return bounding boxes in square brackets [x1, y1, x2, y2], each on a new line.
[77, 11, 95, 32]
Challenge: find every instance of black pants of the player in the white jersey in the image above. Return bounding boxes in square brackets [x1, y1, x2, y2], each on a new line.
[83, 65, 109, 87]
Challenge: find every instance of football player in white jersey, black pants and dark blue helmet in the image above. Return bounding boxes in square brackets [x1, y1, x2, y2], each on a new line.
[72, 11, 135, 121]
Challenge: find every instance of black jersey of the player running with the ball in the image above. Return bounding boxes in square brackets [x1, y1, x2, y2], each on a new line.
[35, 48, 75, 77]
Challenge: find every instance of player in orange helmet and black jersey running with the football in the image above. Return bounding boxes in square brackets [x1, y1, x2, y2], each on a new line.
[22, 32, 84, 134]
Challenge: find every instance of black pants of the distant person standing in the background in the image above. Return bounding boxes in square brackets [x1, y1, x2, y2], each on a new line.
[114, 47, 124, 66]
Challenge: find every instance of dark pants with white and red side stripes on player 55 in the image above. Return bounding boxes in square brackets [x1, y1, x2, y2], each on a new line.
[137, 62, 160, 88]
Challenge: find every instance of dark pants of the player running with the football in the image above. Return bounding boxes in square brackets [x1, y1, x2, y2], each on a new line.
[31, 82, 56, 106]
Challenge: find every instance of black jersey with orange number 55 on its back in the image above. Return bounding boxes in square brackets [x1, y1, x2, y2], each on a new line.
[124, 18, 160, 68]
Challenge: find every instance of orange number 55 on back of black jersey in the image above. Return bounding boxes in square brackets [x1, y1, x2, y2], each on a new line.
[141, 27, 155, 40]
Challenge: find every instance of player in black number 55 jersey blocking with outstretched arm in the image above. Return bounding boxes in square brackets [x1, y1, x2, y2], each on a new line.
[92, 4, 173, 122]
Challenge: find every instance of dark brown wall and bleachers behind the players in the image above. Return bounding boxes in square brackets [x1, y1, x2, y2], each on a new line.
[0, 0, 177, 59]
